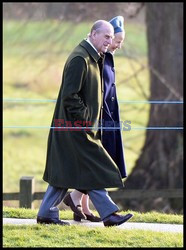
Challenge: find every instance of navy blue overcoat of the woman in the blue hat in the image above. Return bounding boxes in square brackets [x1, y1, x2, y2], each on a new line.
[102, 52, 127, 178]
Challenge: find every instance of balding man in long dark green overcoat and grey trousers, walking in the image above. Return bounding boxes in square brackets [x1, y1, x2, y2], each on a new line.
[37, 20, 132, 226]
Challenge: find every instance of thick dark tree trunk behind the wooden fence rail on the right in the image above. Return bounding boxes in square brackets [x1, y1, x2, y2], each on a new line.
[125, 3, 183, 212]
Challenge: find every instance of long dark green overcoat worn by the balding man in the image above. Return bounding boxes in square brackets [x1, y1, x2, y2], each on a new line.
[43, 40, 123, 190]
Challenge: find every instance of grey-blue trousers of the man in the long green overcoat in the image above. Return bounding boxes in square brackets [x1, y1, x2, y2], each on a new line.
[38, 185, 119, 220]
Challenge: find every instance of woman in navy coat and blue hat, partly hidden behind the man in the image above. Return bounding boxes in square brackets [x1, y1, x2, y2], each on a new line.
[64, 16, 127, 222]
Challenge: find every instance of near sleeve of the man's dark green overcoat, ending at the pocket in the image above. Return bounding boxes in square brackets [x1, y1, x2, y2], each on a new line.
[62, 56, 88, 121]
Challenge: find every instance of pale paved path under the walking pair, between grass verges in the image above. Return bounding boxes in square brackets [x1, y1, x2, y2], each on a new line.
[3, 218, 183, 233]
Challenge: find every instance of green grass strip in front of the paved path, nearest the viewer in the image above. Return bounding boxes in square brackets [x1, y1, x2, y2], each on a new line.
[3, 225, 183, 248]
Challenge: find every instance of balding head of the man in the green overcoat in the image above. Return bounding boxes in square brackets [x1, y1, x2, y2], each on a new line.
[89, 20, 114, 53]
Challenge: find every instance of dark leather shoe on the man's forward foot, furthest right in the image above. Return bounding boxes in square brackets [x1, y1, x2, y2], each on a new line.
[103, 214, 133, 227]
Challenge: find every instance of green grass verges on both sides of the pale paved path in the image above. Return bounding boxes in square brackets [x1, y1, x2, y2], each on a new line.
[3, 207, 183, 248]
